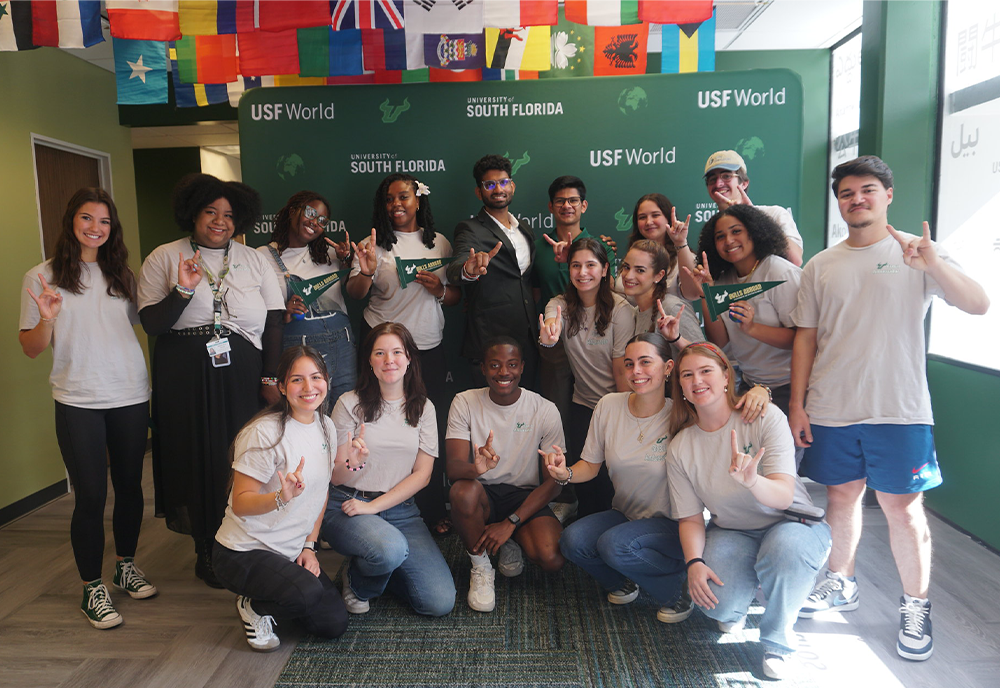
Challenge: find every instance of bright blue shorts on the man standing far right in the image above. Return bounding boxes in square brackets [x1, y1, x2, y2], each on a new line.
[799, 424, 941, 494]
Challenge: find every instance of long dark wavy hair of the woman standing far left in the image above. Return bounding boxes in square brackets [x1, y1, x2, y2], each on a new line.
[52, 187, 136, 302]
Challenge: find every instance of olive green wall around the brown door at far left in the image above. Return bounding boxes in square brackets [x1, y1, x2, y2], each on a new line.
[0, 48, 145, 507]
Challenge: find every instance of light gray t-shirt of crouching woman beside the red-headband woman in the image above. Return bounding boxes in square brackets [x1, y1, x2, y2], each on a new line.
[580, 392, 673, 521]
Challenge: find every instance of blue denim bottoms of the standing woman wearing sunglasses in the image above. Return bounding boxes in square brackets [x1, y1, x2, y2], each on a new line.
[281, 311, 358, 408]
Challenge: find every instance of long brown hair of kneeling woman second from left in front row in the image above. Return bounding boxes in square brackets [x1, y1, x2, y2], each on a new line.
[354, 322, 427, 428]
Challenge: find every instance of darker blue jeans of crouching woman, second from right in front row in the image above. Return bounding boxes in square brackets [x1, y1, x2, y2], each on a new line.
[559, 509, 684, 605]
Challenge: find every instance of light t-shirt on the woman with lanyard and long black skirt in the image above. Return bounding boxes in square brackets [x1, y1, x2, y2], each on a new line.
[139, 242, 285, 349]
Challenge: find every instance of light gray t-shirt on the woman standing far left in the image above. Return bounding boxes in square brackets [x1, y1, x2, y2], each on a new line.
[18, 260, 149, 409]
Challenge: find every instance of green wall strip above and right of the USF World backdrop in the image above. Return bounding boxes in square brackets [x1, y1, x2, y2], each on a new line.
[715, 50, 830, 259]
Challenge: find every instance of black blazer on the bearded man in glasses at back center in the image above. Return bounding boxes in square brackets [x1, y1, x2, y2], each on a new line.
[448, 208, 538, 361]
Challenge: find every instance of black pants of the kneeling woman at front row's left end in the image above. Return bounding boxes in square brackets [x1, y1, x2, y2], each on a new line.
[212, 542, 347, 638]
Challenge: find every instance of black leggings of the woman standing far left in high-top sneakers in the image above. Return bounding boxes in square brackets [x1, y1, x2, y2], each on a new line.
[56, 401, 149, 582]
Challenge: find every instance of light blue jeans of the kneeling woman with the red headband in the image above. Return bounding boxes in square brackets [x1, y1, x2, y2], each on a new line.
[702, 521, 830, 654]
